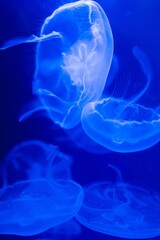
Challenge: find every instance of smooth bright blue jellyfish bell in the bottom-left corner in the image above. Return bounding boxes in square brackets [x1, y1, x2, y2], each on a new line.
[0, 179, 83, 236]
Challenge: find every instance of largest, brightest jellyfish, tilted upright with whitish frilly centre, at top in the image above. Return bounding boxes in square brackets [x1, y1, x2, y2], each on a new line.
[1, 0, 113, 129]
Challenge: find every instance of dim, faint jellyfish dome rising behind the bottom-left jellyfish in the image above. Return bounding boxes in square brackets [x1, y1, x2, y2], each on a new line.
[3, 140, 72, 184]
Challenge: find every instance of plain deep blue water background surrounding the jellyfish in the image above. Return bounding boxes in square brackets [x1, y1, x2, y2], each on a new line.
[0, 0, 160, 240]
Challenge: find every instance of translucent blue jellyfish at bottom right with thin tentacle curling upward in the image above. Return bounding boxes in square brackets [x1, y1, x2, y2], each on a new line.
[76, 165, 160, 239]
